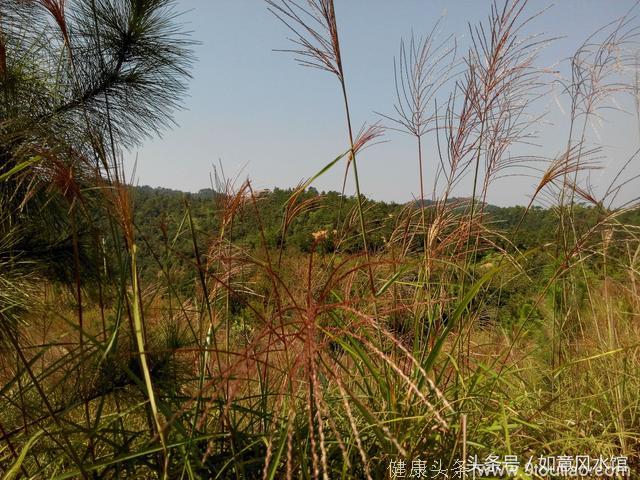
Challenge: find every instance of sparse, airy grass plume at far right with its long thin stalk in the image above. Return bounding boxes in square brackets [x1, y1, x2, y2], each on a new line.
[551, 8, 640, 367]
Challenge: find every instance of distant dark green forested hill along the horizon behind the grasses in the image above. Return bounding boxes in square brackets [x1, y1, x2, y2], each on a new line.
[133, 186, 640, 278]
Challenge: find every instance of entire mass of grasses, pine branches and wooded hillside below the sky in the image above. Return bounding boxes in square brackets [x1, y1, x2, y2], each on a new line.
[0, 0, 640, 480]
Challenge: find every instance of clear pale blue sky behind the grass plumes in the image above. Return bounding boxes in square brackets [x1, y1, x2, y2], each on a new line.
[126, 0, 640, 205]
